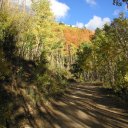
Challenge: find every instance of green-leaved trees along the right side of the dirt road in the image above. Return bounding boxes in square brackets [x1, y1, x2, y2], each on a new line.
[73, 14, 128, 94]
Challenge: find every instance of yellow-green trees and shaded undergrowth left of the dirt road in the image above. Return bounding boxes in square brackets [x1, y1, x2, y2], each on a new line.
[0, 0, 74, 128]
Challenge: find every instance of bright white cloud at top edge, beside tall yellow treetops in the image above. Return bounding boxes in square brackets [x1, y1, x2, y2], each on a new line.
[50, 0, 70, 19]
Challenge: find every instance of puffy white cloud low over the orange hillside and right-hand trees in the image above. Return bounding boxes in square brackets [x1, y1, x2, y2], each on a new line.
[85, 16, 111, 30]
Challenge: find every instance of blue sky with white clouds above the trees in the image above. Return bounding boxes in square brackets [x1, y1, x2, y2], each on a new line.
[50, 0, 128, 30]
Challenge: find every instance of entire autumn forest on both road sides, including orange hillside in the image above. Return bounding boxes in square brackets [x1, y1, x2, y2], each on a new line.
[0, 0, 128, 128]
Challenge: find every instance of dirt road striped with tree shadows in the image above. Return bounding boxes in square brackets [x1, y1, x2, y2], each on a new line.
[40, 84, 128, 128]
